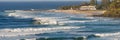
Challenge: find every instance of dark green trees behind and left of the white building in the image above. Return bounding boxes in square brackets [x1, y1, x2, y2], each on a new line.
[59, 0, 101, 10]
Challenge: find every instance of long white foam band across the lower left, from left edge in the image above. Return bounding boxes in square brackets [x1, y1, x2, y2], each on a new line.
[0, 27, 80, 37]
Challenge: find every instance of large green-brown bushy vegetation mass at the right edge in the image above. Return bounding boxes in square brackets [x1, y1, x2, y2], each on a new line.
[102, 0, 120, 17]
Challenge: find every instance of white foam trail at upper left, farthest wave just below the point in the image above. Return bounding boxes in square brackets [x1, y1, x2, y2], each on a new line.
[8, 12, 66, 19]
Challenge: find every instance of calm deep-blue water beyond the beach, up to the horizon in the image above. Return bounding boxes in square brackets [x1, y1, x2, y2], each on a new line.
[0, 1, 82, 10]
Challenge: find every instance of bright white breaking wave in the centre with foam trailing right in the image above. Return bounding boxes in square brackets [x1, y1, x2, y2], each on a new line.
[33, 17, 97, 25]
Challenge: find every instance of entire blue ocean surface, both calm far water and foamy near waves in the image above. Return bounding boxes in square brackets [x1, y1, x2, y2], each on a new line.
[0, 2, 120, 40]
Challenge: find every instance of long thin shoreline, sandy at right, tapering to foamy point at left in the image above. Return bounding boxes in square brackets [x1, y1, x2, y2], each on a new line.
[3, 9, 106, 16]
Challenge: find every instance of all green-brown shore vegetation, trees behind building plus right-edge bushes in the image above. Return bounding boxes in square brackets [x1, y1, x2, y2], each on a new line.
[59, 0, 120, 17]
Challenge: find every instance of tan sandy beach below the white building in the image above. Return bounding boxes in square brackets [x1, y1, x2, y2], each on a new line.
[47, 10, 106, 16]
